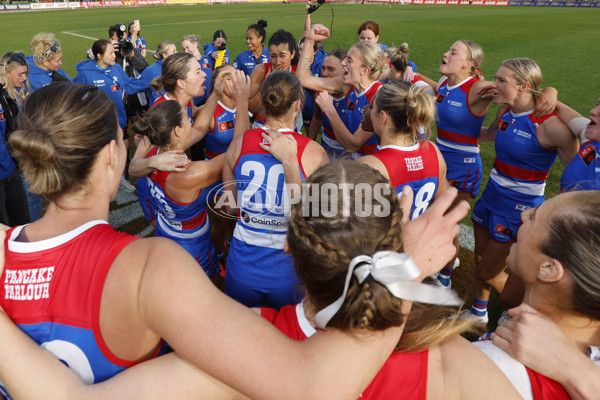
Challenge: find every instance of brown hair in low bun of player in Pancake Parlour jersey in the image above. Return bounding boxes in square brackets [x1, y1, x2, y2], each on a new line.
[9, 82, 119, 201]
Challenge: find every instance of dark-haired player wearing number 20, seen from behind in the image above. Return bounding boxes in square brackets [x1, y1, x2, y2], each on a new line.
[223, 70, 328, 308]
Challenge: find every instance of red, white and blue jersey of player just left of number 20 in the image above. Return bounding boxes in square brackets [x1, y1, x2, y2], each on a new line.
[147, 147, 216, 276]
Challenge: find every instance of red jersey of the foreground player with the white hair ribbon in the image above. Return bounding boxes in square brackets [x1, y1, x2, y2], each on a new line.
[261, 304, 429, 400]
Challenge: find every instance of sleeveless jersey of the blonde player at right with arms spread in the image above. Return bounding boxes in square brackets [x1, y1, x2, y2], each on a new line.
[482, 109, 558, 214]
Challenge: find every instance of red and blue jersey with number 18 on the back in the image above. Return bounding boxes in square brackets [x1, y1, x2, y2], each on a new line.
[373, 142, 440, 219]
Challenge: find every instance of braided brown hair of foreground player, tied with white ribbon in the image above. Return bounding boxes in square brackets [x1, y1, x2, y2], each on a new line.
[287, 160, 475, 350]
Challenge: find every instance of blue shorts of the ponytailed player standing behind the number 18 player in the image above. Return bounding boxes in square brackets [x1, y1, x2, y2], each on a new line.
[440, 149, 483, 198]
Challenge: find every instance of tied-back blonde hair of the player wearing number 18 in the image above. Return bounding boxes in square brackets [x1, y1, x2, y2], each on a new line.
[375, 81, 436, 143]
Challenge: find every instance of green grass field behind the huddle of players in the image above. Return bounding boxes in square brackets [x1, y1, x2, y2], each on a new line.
[0, 3, 600, 327]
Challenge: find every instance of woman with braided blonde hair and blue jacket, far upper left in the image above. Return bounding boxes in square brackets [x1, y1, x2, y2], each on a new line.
[27, 32, 71, 90]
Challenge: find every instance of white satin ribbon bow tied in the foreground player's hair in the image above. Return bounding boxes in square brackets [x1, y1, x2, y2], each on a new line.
[315, 251, 462, 329]
